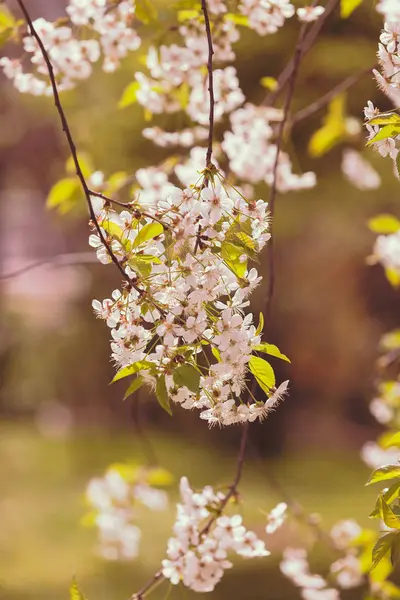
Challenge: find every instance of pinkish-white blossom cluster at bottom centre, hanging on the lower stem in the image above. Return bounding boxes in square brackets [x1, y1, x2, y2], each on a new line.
[162, 477, 270, 592]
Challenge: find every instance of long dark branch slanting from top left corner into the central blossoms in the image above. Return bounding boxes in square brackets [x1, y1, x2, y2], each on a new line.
[17, 0, 134, 293]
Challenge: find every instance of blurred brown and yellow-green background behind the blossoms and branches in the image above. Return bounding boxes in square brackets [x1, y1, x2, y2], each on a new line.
[0, 0, 400, 600]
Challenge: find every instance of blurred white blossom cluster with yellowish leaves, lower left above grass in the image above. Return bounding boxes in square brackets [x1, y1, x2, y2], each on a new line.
[84, 465, 168, 560]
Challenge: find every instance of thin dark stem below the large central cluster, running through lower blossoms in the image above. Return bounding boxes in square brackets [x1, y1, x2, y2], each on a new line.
[129, 422, 249, 600]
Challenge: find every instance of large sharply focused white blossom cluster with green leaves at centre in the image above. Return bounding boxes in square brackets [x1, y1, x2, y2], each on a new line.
[89, 169, 287, 425]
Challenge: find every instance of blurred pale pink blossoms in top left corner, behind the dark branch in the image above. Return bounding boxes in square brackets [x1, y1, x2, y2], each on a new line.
[0, 0, 141, 95]
